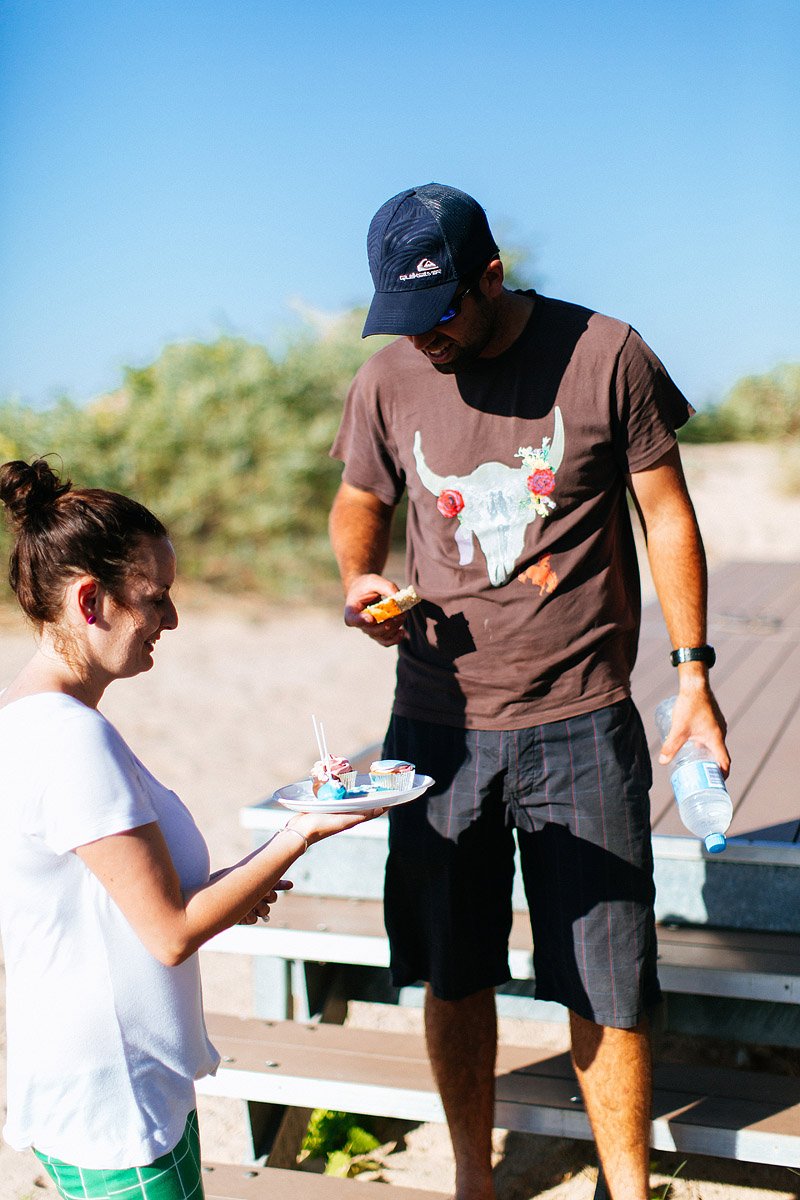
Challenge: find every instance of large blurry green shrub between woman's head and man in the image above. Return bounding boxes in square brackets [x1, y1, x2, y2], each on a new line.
[0, 313, 398, 595]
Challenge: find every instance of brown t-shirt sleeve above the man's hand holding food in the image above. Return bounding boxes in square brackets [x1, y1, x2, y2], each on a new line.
[331, 360, 405, 508]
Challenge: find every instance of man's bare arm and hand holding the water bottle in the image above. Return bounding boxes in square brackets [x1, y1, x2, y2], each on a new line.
[628, 446, 730, 775]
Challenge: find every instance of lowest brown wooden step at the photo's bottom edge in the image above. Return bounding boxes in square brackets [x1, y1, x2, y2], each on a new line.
[203, 1163, 444, 1200]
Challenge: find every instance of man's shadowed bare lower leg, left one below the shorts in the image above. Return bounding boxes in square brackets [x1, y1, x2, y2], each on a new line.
[425, 988, 498, 1200]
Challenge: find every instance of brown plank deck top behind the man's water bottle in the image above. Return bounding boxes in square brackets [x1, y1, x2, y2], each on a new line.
[633, 563, 800, 844]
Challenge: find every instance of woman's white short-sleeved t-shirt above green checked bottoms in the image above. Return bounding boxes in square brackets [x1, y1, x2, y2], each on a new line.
[0, 692, 219, 1169]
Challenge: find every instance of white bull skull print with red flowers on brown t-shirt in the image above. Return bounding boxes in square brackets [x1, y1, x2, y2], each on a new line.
[414, 408, 564, 588]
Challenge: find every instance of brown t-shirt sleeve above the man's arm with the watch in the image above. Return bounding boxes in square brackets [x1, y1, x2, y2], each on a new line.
[615, 329, 694, 474]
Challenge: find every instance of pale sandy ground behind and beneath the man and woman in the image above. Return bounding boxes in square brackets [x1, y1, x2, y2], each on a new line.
[0, 445, 800, 1200]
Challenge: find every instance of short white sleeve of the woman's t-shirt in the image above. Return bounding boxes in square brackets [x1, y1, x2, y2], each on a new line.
[41, 710, 157, 854]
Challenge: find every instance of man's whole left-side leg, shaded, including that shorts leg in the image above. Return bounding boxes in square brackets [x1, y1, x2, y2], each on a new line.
[384, 716, 515, 1200]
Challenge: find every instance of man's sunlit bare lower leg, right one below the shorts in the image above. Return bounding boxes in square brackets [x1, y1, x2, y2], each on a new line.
[570, 1013, 652, 1200]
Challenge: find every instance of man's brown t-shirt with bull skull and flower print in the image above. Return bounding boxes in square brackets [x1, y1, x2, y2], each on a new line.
[331, 296, 692, 730]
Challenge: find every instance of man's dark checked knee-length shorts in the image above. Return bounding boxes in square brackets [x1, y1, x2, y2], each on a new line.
[384, 700, 660, 1028]
